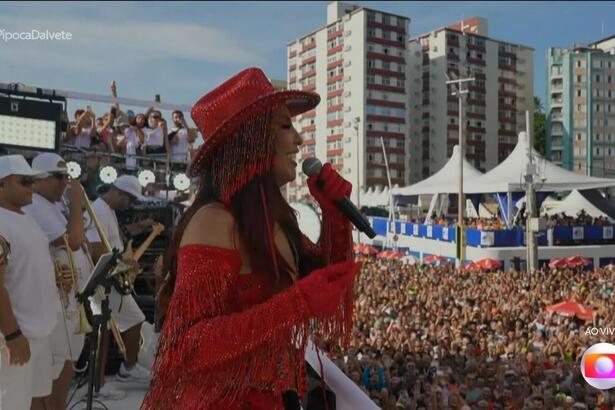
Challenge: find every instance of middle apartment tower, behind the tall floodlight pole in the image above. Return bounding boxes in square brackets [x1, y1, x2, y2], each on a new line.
[408, 17, 534, 182]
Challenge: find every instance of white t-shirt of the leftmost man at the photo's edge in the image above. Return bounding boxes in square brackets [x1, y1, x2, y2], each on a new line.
[0, 207, 61, 338]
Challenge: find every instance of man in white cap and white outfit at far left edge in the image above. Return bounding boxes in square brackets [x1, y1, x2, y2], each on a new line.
[0, 155, 61, 410]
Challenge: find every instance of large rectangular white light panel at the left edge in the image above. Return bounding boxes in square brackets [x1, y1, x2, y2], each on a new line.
[0, 115, 56, 150]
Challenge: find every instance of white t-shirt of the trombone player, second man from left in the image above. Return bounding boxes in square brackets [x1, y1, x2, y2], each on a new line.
[23, 193, 93, 286]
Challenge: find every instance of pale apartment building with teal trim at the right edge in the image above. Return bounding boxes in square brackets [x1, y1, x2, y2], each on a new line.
[545, 36, 615, 178]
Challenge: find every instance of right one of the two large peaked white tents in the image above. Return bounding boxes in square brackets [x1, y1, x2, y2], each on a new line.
[464, 132, 615, 194]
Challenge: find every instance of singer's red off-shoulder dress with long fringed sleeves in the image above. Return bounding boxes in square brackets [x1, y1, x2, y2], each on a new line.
[141, 214, 352, 410]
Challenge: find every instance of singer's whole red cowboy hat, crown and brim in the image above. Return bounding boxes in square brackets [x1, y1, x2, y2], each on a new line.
[189, 68, 320, 176]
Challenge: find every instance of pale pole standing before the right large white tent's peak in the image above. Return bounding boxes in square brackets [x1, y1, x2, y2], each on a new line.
[525, 111, 538, 272]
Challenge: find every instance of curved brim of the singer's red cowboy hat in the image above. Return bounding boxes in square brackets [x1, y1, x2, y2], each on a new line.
[188, 90, 320, 177]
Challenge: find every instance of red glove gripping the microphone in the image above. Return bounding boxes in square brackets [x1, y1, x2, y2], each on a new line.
[308, 163, 352, 213]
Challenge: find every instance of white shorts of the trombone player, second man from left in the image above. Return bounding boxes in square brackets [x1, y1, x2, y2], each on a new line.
[49, 312, 85, 380]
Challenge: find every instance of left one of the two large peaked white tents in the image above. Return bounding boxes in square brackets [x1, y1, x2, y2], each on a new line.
[393, 145, 483, 197]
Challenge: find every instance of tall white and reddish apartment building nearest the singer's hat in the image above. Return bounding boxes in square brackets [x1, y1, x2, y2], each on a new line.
[288, 2, 409, 201]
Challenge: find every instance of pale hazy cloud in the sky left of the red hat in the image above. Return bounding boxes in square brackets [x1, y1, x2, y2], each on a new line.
[0, 14, 261, 74]
